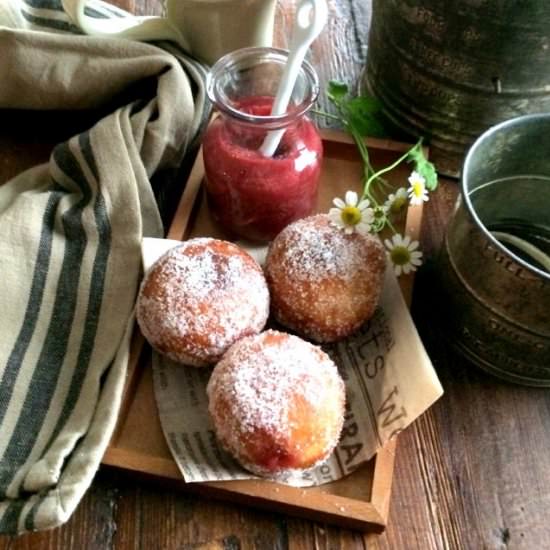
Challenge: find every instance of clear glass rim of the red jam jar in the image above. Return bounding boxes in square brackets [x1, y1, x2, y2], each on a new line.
[206, 47, 320, 127]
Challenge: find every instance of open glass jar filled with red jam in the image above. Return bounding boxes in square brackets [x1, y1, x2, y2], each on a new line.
[203, 48, 323, 245]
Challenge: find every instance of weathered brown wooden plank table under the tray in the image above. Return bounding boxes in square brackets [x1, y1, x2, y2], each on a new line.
[0, 0, 550, 550]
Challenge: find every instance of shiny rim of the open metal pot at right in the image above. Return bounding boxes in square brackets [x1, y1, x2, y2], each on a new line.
[460, 113, 550, 283]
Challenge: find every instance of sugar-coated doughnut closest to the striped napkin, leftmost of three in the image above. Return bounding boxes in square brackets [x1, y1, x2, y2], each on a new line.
[136, 238, 269, 366]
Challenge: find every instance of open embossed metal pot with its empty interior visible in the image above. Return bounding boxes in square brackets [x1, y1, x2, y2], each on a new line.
[438, 113, 550, 386]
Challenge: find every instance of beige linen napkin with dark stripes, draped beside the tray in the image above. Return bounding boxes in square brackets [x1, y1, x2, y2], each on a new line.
[0, 0, 206, 533]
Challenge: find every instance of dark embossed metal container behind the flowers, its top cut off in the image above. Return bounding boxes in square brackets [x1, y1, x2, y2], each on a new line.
[362, 0, 550, 175]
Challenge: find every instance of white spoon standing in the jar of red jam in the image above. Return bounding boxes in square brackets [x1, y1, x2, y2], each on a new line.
[260, 0, 328, 157]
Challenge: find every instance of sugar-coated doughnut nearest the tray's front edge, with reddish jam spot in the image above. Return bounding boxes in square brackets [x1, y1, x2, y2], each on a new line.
[207, 330, 345, 479]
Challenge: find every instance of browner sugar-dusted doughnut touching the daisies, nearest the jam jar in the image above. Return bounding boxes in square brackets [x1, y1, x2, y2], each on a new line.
[265, 214, 386, 342]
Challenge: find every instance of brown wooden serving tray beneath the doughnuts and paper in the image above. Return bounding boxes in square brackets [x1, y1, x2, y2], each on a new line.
[103, 130, 422, 531]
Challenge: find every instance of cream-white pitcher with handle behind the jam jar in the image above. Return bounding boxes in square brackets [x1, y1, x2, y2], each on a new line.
[62, 0, 276, 64]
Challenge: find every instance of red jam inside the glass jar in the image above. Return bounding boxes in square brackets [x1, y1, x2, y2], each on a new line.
[203, 97, 323, 241]
